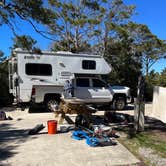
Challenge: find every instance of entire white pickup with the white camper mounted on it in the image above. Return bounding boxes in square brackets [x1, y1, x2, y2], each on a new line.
[9, 49, 130, 109]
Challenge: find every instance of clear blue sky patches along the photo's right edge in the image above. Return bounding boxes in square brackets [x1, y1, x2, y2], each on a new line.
[125, 0, 166, 72]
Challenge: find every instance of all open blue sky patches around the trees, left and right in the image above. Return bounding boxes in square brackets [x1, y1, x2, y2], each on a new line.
[0, 0, 166, 71]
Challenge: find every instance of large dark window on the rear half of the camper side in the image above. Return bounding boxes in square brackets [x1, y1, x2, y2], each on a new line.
[25, 63, 52, 76]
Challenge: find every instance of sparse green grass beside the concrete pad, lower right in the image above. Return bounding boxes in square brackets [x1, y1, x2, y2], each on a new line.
[119, 132, 166, 165]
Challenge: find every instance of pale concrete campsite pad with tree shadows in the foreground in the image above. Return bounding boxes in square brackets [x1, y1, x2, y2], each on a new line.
[0, 107, 139, 166]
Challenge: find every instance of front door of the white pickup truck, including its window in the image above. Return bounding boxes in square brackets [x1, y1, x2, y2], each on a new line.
[90, 78, 112, 102]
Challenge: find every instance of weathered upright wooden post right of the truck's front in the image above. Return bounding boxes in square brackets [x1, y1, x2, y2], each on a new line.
[134, 76, 145, 132]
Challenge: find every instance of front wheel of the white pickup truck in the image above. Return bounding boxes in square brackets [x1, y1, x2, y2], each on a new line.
[113, 97, 126, 110]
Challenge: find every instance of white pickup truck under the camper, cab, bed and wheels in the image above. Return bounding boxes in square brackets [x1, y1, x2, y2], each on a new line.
[32, 76, 131, 110]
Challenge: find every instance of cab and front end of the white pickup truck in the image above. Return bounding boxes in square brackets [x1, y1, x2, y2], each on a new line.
[61, 77, 131, 110]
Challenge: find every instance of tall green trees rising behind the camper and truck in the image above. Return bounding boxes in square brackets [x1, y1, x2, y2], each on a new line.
[0, 0, 166, 105]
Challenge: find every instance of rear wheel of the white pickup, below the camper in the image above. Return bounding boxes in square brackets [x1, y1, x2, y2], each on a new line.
[45, 99, 59, 112]
